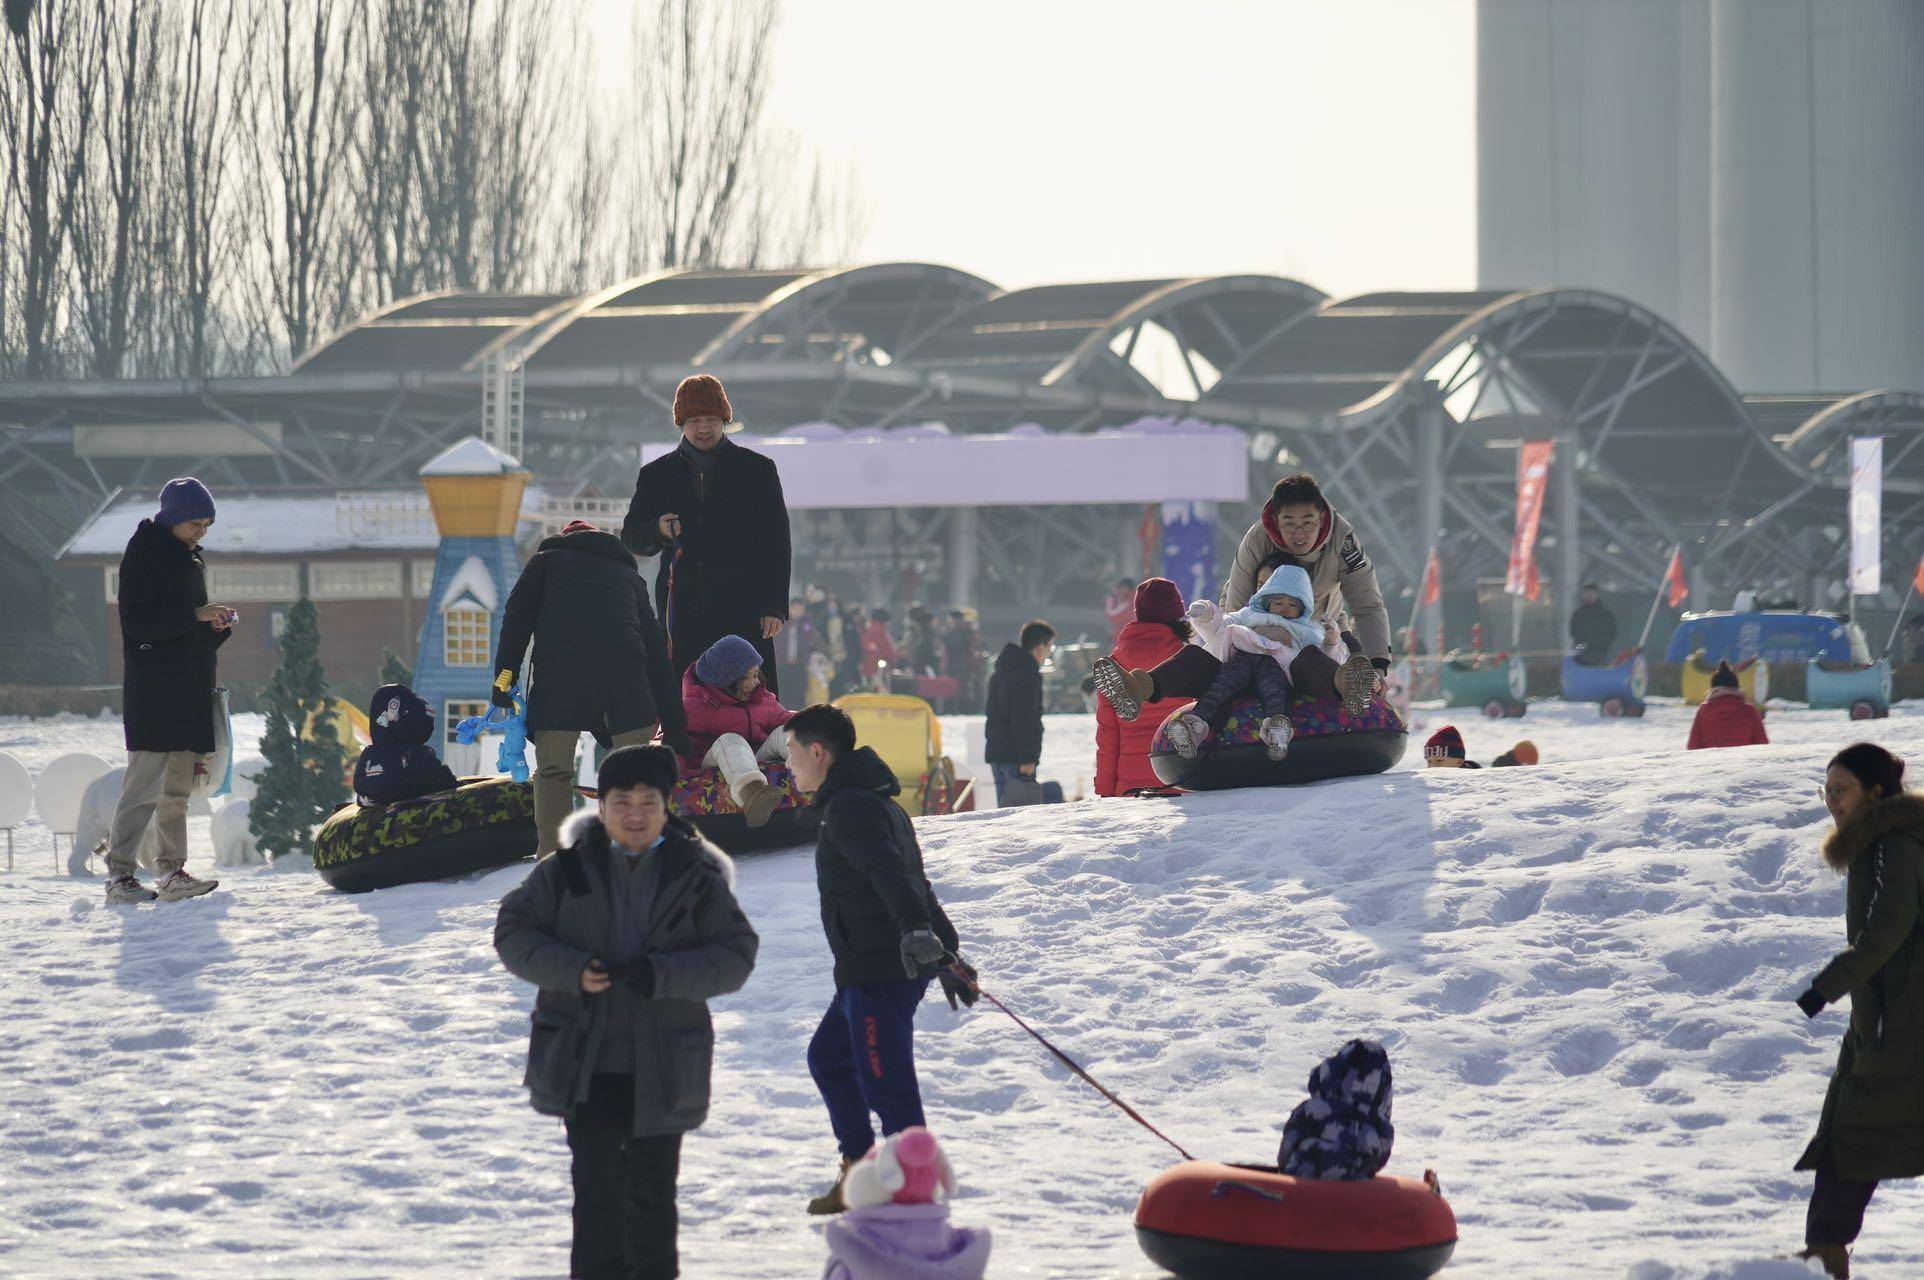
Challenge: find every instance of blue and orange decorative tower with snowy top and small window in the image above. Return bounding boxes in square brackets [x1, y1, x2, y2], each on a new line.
[414, 435, 527, 758]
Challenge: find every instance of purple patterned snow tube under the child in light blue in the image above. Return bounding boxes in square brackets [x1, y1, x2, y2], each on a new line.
[1149, 699, 1408, 791]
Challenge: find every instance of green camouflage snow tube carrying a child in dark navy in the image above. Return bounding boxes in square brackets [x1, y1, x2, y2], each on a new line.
[314, 778, 535, 893]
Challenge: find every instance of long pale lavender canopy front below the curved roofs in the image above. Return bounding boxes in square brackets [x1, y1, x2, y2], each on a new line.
[641, 418, 1249, 510]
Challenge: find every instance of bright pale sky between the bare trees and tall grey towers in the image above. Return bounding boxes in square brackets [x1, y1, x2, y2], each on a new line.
[593, 0, 1476, 296]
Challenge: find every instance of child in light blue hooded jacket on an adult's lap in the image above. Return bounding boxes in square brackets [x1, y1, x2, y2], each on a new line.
[1162, 564, 1335, 760]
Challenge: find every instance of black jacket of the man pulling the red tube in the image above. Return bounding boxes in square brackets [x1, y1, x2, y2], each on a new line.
[814, 747, 958, 987]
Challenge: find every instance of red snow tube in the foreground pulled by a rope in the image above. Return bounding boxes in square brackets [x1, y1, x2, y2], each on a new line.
[1135, 1161, 1456, 1280]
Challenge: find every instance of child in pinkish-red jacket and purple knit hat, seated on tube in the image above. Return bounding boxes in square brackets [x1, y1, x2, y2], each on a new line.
[681, 635, 795, 826]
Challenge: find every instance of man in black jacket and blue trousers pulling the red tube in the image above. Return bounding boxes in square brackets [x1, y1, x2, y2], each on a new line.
[787, 704, 975, 1215]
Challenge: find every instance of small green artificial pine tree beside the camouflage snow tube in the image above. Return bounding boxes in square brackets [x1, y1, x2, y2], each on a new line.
[248, 597, 348, 858]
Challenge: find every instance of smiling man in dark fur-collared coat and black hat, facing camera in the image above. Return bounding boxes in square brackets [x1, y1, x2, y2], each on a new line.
[494, 747, 760, 1280]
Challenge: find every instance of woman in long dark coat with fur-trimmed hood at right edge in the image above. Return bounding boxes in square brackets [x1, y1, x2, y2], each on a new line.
[1797, 743, 1924, 1276]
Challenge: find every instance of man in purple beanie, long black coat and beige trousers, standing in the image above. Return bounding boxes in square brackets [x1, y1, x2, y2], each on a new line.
[108, 475, 241, 903]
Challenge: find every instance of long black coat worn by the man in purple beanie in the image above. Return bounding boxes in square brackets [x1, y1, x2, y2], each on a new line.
[119, 520, 229, 755]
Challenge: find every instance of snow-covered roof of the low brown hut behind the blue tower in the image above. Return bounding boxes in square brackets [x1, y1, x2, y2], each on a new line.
[56, 485, 548, 560]
